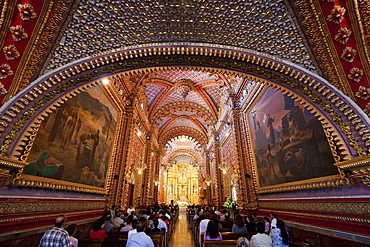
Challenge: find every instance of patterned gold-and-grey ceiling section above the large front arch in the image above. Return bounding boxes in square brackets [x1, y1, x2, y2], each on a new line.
[47, 0, 314, 72]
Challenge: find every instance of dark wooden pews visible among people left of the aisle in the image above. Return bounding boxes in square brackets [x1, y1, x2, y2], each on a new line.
[78, 208, 179, 247]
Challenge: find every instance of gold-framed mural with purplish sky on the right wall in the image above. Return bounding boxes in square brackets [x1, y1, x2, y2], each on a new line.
[248, 88, 338, 187]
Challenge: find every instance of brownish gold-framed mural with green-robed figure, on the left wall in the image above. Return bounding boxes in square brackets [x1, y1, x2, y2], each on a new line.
[24, 86, 117, 187]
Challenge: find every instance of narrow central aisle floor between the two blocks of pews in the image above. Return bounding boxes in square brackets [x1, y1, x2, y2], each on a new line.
[168, 208, 194, 247]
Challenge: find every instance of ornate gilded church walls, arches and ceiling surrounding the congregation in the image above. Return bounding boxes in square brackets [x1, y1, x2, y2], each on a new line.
[0, 0, 370, 246]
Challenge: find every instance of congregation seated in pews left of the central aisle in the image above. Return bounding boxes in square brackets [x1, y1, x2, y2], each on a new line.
[39, 203, 179, 247]
